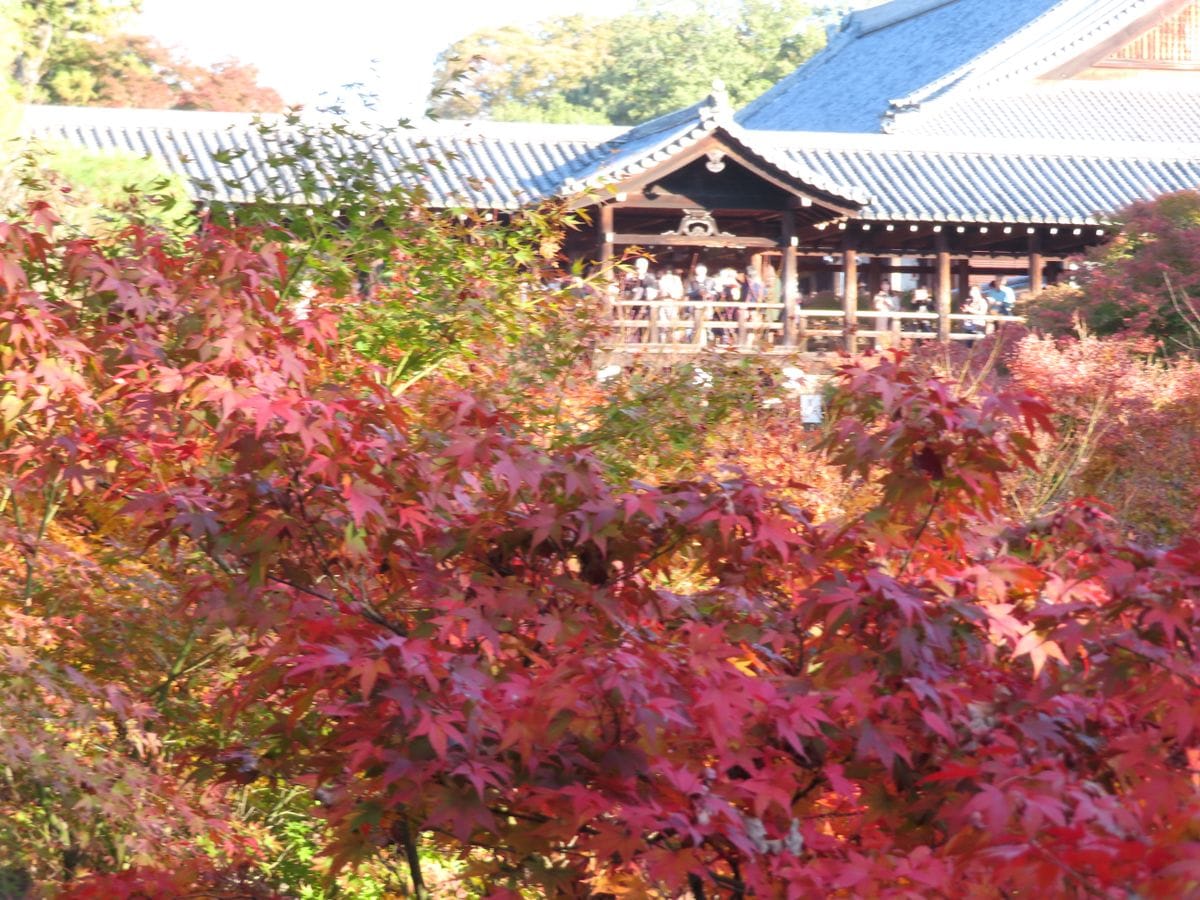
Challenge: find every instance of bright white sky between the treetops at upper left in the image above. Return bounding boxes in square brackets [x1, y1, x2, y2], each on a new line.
[131, 0, 648, 118]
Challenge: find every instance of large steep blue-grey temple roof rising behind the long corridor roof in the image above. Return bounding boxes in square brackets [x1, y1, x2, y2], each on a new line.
[737, 0, 1200, 140]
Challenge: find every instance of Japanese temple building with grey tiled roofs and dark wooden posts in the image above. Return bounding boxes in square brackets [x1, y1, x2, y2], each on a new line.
[26, 0, 1200, 346]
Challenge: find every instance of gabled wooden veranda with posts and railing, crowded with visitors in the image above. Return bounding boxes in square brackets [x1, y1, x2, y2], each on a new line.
[569, 117, 1105, 353]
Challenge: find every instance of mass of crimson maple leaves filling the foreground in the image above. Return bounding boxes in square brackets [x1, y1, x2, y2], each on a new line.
[0, 204, 1200, 898]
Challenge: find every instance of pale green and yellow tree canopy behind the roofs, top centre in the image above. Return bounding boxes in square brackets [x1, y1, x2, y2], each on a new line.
[433, 0, 833, 125]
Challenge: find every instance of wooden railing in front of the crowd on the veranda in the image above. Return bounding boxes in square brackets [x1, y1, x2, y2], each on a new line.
[612, 300, 1025, 352]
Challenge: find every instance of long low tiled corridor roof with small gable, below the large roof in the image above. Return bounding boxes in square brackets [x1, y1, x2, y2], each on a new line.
[16, 100, 1200, 226]
